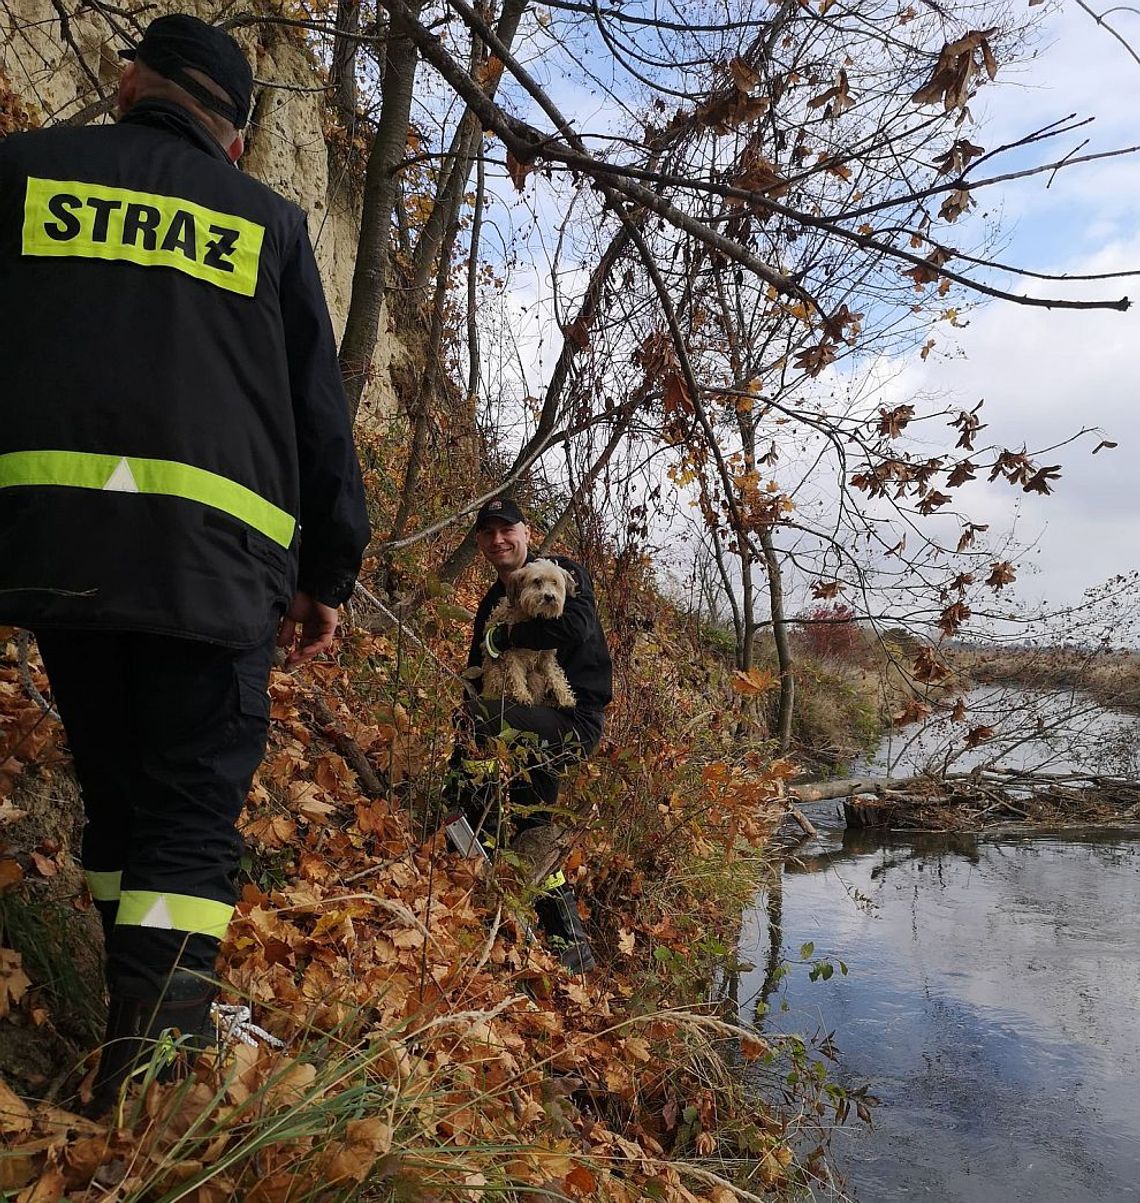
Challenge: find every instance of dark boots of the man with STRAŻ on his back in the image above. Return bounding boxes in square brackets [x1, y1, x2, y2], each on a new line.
[87, 970, 218, 1119]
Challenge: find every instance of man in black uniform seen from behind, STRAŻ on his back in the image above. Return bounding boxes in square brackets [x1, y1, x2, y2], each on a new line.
[0, 14, 368, 1109]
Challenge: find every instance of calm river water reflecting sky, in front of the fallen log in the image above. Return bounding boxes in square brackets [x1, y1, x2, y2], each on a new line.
[738, 692, 1140, 1203]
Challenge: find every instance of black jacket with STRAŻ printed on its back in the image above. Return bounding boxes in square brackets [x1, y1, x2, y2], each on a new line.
[0, 101, 368, 647]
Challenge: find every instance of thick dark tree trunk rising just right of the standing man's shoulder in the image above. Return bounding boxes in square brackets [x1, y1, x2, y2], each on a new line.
[340, 0, 424, 419]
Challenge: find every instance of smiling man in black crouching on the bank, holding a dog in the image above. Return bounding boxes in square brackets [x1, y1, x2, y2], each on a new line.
[455, 497, 613, 973]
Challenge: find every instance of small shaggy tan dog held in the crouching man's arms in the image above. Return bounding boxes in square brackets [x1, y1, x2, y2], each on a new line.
[482, 559, 578, 710]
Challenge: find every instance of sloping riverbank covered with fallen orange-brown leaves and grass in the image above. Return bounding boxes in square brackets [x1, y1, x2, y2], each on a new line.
[0, 591, 836, 1203]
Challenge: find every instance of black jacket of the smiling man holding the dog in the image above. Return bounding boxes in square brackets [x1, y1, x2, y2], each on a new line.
[467, 555, 613, 715]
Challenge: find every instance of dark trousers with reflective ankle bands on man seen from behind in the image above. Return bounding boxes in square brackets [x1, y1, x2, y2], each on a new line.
[36, 630, 273, 990]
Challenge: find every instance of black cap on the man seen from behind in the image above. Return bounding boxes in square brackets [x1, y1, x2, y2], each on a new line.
[119, 12, 254, 130]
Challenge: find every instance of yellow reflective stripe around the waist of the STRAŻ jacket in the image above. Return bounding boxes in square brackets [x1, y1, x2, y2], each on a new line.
[0, 451, 297, 547]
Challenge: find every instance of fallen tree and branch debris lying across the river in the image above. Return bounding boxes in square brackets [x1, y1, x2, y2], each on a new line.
[790, 769, 1140, 831]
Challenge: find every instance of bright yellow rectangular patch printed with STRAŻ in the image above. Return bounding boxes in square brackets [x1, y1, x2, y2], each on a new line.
[23, 176, 266, 297]
